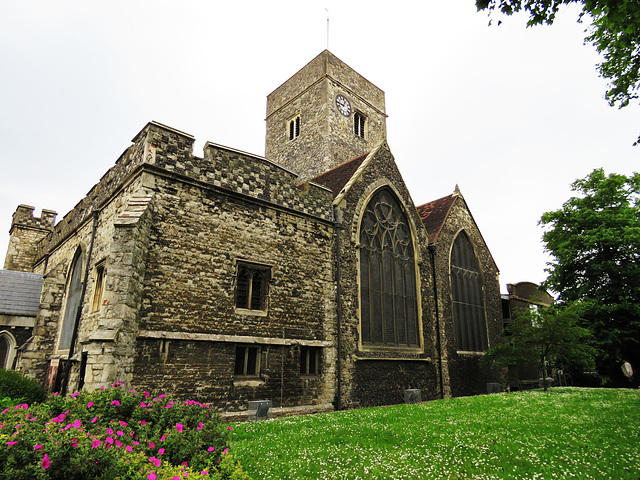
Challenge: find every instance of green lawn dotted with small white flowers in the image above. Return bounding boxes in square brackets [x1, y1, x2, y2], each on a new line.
[231, 388, 640, 480]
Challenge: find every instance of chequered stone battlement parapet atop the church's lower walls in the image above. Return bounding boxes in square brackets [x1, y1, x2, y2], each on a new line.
[26, 122, 331, 262]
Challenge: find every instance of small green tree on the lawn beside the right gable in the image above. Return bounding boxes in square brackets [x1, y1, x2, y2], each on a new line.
[483, 303, 596, 391]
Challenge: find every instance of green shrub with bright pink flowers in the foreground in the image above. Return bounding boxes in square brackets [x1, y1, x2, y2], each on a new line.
[0, 386, 248, 480]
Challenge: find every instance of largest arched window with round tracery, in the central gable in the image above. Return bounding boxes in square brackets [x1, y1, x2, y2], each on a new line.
[360, 188, 420, 347]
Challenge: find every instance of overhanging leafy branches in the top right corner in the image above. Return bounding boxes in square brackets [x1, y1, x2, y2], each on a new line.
[476, 0, 640, 145]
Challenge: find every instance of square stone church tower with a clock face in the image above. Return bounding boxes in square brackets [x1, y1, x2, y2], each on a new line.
[265, 50, 387, 181]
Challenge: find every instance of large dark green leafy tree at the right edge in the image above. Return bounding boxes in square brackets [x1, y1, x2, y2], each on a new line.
[540, 169, 640, 361]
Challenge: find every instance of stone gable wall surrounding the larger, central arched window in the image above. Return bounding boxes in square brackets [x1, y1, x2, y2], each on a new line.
[336, 146, 438, 407]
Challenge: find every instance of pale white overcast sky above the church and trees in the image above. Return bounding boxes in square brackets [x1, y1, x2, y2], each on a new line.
[0, 0, 640, 291]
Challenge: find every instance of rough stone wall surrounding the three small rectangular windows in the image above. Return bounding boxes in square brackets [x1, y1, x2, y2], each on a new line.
[134, 169, 335, 409]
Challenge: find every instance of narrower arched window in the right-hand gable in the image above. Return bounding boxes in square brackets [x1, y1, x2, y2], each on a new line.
[451, 232, 487, 352]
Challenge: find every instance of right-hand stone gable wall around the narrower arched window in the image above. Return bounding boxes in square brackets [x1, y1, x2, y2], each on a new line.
[435, 197, 502, 397]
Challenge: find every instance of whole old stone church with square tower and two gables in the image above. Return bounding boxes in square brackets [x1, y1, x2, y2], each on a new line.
[0, 51, 502, 412]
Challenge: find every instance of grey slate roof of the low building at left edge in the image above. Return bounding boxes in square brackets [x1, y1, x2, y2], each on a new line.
[0, 270, 43, 316]
